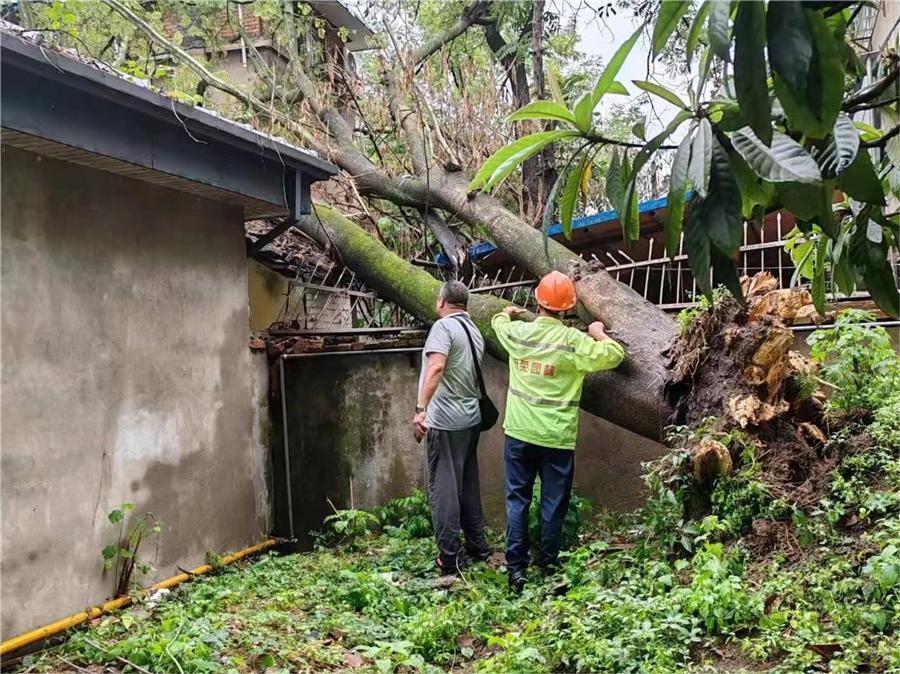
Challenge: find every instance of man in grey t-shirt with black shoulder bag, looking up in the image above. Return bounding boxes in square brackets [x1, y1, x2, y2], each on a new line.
[413, 281, 489, 574]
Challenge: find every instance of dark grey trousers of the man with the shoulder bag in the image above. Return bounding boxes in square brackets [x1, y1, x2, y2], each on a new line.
[426, 426, 489, 570]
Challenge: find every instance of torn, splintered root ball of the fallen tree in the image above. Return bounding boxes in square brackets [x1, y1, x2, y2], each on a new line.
[666, 273, 839, 505]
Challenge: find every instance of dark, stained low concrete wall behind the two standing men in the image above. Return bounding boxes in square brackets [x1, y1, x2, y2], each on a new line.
[272, 346, 662, 543]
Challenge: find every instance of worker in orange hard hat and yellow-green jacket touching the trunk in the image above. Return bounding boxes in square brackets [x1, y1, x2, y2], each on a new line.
[491, 271, 625, 592]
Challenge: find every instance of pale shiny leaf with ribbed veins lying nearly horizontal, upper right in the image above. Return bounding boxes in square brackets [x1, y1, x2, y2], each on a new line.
[731, 127, 822, 184]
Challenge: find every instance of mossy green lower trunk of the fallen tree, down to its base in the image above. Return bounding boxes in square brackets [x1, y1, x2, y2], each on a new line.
[297, 200, 675, 440]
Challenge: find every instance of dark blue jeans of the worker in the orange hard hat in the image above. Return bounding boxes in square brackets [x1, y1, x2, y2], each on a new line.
[503, 435, 575, 573]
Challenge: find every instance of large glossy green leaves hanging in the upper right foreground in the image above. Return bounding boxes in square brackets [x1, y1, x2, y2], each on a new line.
[472, 0, 900, 316]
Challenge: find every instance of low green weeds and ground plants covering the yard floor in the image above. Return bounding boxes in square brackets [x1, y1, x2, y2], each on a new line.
[20, 316, 900, 673]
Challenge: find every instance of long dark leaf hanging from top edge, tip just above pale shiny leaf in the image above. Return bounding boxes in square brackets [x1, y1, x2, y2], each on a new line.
[734, 0, 772, 145]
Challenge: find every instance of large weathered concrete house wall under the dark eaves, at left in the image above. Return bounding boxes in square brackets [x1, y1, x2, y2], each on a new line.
[0, 147, 269, 638]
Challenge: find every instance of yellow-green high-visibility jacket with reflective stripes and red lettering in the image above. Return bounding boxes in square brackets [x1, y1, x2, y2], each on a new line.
[491, 313, 625, 449]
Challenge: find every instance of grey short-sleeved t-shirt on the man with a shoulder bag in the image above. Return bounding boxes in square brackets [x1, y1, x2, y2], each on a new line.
[419, 313, 484, 431]
